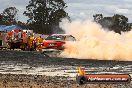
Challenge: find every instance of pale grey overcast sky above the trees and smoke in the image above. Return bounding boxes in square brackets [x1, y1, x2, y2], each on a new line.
[0, 0, 132, 22]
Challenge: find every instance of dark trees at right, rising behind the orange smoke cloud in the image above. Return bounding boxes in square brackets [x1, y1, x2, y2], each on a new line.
[94, 14, 131, 34]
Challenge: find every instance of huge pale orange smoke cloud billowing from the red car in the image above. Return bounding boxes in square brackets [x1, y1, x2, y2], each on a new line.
[60, 20, 132, 61]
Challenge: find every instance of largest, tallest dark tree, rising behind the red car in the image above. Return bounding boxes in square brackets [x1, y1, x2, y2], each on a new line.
[24, 0, 68, 34]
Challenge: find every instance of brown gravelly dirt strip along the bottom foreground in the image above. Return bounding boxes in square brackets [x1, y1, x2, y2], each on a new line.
[0, 74, 131, 88]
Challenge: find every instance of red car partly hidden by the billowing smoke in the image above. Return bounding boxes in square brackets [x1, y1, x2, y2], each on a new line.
[43, 34, 76, 50]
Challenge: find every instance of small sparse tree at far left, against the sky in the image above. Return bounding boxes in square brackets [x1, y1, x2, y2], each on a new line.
[2, 7, 18, 24]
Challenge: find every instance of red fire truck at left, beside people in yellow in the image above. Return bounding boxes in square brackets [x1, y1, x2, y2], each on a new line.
[6, 29, 32, 50]
